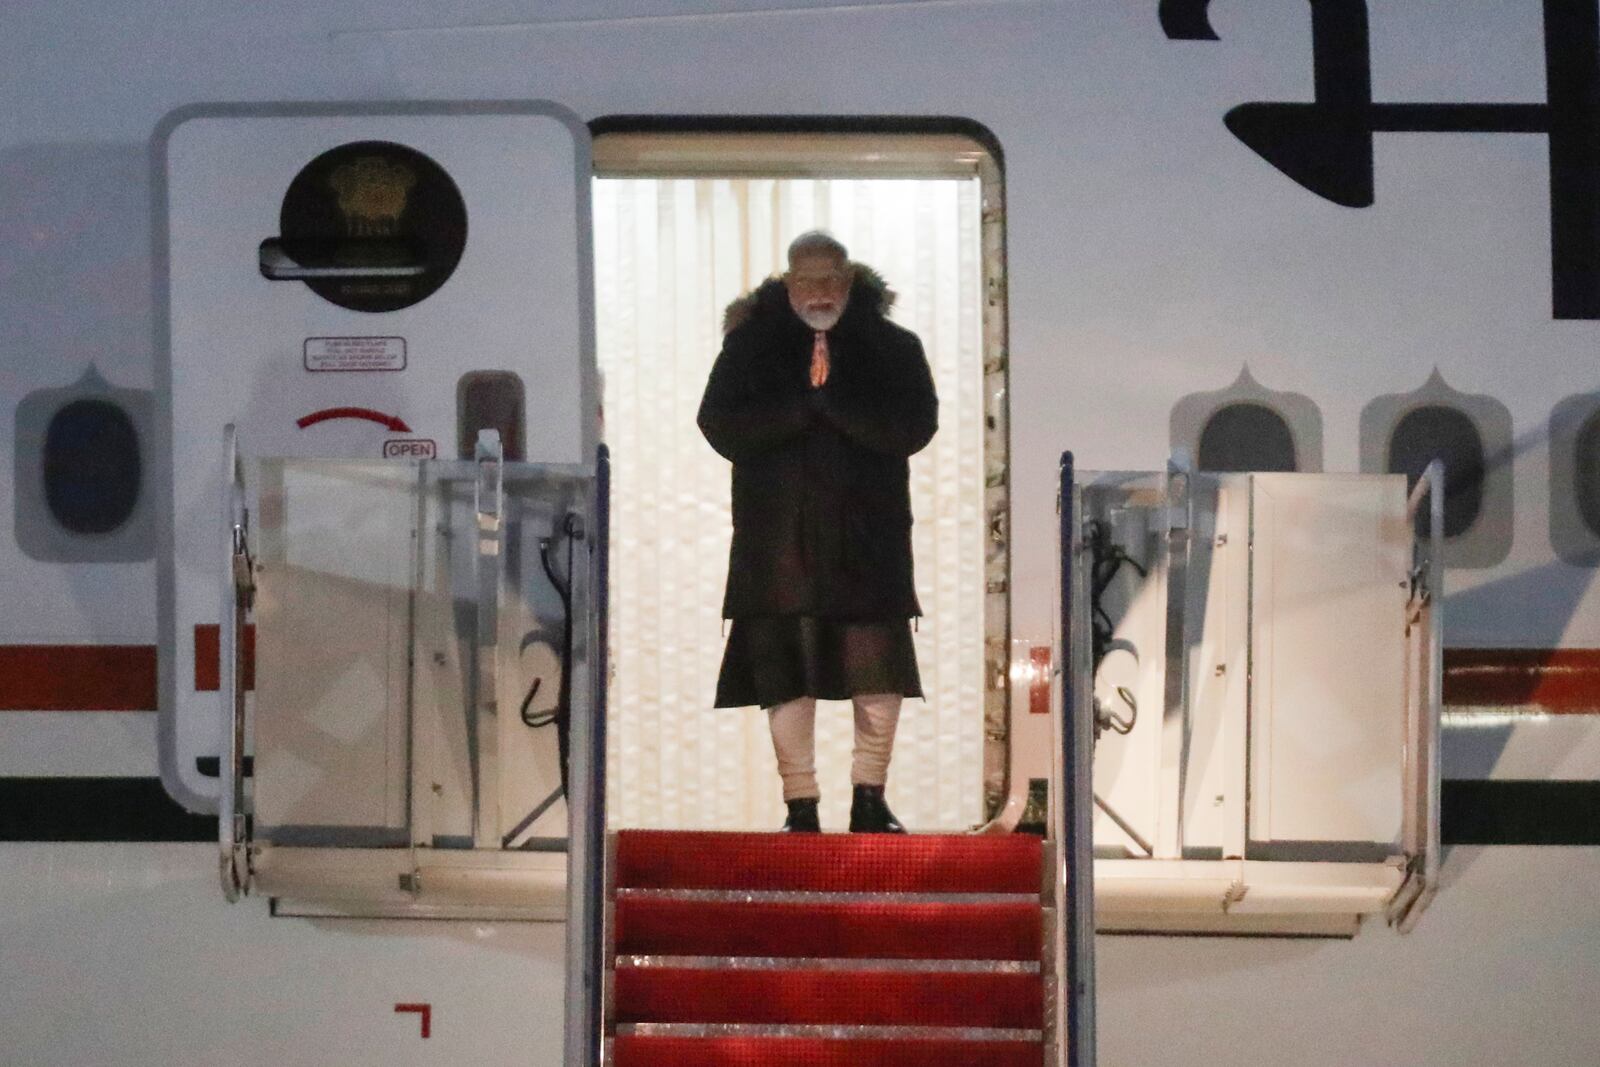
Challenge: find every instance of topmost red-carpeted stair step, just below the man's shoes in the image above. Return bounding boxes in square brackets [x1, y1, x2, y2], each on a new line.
[616, 830, 1042, 899]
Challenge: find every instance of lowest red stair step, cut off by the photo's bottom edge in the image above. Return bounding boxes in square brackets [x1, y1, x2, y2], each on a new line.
[611, 1035, 1045, 1067]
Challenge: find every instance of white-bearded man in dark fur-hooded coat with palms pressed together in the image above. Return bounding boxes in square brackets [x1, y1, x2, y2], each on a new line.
[699, 230, 939, 833]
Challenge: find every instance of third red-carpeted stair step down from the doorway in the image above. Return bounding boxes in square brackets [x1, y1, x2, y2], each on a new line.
[613, 966, 1045, 1030]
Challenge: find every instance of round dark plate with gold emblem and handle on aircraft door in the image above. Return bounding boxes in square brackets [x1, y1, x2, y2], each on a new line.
[278, 141, 467, 312]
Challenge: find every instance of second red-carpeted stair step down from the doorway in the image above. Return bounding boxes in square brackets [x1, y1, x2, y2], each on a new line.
[614, 896, 1042, 960]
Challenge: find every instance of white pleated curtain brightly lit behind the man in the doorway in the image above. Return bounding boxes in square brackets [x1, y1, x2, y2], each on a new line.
[594, 178, 984, 830]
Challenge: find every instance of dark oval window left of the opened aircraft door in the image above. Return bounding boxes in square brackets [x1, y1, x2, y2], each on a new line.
[43, 400, 144, 534]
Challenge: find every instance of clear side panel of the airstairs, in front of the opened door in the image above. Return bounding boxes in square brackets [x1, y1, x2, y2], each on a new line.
[253, 459, 587, 849]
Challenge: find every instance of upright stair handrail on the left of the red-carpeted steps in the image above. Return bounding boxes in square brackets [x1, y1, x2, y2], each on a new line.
[562, 445, 611, 1067]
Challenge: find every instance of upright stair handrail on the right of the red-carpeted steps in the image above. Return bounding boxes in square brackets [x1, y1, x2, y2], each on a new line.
[1050, 451, 1094, 1067]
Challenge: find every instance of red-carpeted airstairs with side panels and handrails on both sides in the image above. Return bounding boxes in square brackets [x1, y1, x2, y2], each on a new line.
[206, 430, 1443, 1067]
